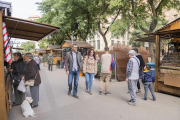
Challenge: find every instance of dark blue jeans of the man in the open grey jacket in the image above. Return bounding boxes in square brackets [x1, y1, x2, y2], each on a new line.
[68, 71, 80, 95]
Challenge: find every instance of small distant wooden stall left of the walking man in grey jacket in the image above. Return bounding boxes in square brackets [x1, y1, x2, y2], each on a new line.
[46, 45, 61, 65]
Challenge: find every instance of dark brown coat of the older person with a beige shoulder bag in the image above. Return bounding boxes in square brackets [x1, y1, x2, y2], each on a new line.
[24, 59, 41, 86]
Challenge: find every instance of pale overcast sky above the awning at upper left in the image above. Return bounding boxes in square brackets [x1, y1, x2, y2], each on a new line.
[2, 0, 42, 19]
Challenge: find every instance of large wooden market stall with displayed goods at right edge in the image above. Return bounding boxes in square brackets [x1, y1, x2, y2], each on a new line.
[136, 18, 180, 96]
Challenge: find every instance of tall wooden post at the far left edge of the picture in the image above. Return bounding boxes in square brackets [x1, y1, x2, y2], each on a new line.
[0, 10, 7, 120]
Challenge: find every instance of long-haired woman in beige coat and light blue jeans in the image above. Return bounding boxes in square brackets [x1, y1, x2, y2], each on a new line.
[83, 49, 97, 95]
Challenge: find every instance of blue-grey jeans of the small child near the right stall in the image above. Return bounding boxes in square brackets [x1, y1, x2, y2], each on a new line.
[144, 82, 156, 100]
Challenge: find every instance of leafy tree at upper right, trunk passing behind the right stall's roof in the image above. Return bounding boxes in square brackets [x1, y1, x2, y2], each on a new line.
[111, 0, 180, 62]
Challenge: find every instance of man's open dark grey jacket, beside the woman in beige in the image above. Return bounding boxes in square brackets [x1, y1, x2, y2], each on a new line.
[65, 51, 83, 73]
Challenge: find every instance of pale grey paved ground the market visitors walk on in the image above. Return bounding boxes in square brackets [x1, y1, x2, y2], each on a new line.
[9, 66, 180, 120]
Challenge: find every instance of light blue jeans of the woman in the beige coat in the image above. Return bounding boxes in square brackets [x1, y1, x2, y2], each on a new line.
[85, 73, 94, 91]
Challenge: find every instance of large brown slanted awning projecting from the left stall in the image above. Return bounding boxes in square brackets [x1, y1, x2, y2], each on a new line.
[3, 16, 60, 41]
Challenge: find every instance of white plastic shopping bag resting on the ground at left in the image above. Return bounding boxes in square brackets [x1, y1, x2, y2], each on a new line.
[21, 100, 35, 117]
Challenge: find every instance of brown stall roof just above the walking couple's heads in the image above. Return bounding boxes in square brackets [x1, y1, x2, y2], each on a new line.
[61, 40, 94, 48]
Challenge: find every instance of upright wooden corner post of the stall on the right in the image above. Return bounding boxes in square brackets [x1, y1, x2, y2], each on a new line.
[155, 35, 160, 92]
